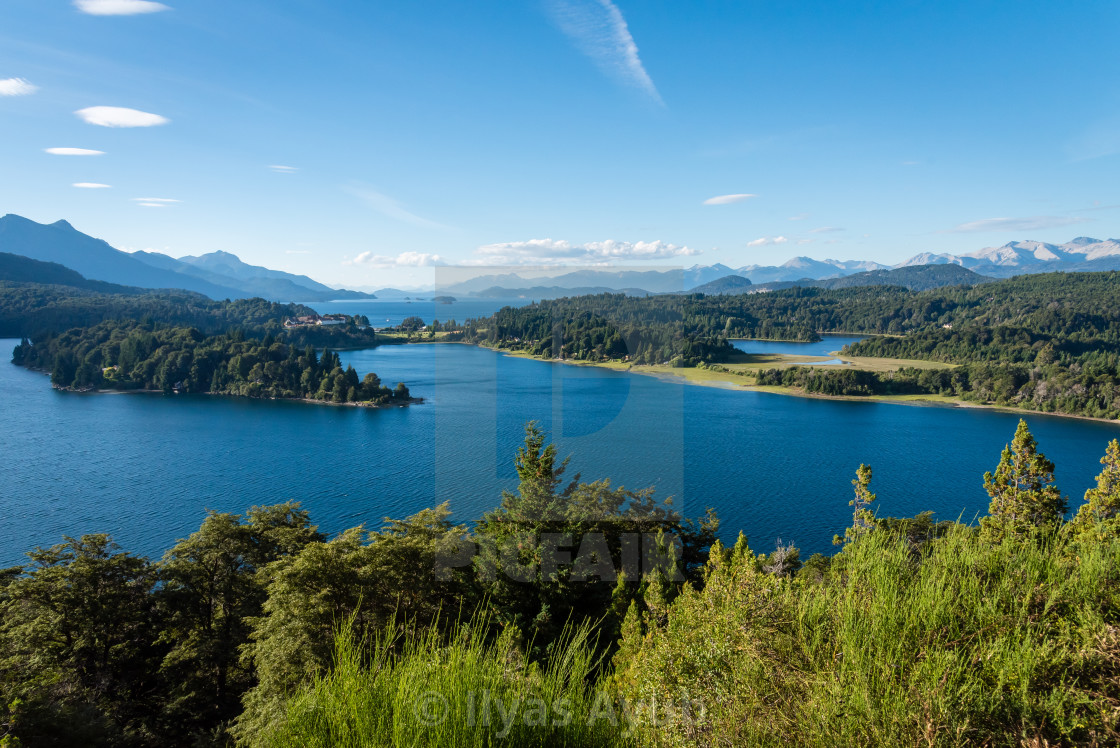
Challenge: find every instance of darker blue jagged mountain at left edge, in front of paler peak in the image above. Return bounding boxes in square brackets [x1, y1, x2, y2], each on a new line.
[0, 214, 250, 299]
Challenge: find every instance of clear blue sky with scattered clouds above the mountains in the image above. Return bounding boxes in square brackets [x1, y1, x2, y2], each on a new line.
[0, 0, 1120, 287]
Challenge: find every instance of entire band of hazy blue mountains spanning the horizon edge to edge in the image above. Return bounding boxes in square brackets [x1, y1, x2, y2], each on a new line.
[0, 215, 1120, 301]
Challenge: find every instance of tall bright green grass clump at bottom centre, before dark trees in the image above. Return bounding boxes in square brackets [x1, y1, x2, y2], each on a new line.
[252, 618, 627, 748]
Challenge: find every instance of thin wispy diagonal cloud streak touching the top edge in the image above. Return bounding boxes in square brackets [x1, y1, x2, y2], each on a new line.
[548, 0, 665, 105]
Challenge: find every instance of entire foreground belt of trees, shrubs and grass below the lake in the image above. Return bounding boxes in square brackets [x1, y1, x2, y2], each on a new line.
[0, 421, 1120, 748]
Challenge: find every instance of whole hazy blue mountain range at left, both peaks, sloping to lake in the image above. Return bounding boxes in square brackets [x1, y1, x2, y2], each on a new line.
[0, 215, 376, 301]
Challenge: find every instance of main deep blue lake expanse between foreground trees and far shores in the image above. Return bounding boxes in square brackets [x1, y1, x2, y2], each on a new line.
[0, 340, 1120, 567]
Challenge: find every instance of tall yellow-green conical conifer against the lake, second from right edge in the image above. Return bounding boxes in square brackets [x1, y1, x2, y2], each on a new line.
[980, 419, 1066, 541]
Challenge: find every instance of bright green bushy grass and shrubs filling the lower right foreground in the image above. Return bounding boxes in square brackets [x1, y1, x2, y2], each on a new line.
[617, 529, 1120, 747]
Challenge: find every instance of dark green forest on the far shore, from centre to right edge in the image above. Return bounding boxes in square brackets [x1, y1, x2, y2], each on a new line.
[467, 272, 1120, 419]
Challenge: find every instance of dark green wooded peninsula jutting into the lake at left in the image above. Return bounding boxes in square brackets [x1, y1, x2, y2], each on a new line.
[12, 322, 410, 403]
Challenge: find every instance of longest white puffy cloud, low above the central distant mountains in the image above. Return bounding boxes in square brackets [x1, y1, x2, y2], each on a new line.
[475, 239, 700, 265]
